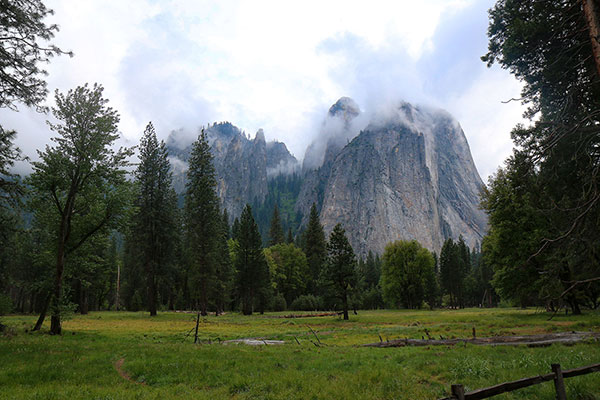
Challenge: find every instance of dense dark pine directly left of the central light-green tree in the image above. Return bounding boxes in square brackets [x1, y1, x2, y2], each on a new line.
[235, 204, 270, 315]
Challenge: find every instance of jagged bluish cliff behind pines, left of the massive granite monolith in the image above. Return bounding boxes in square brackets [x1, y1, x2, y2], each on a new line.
[167, 122, 299, 218]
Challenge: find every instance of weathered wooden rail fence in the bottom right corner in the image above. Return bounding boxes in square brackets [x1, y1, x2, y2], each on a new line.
[440, 364, 600, 400]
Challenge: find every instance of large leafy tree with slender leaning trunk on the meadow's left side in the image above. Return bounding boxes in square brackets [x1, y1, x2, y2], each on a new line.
[27, 85, 131, 334]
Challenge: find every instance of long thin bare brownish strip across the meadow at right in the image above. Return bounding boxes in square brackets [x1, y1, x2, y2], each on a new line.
[363, 332, 600, 347]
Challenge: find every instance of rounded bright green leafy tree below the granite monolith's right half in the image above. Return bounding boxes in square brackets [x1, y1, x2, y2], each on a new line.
[381, 240, 435, 308]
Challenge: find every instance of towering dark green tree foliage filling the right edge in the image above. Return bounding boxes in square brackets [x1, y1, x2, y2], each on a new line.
[483, 0, 600, 313]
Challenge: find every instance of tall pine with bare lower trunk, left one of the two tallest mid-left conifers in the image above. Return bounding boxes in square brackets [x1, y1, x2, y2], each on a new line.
[132, 122, 178, 316]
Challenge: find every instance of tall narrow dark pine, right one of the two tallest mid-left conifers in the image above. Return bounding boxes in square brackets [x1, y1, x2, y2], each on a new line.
[184, 129, 221, 315]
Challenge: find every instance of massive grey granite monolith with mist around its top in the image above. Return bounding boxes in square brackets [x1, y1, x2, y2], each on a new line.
[296, 101, 487, 254]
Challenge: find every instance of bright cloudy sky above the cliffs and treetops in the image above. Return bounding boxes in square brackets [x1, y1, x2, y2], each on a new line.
[0, 0, 524, 181]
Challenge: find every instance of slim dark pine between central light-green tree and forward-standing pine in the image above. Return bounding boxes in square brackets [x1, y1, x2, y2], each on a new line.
[303, 203, 327, 295]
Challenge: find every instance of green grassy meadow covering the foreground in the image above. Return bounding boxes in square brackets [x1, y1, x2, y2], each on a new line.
[0, 309, 600, 400]
